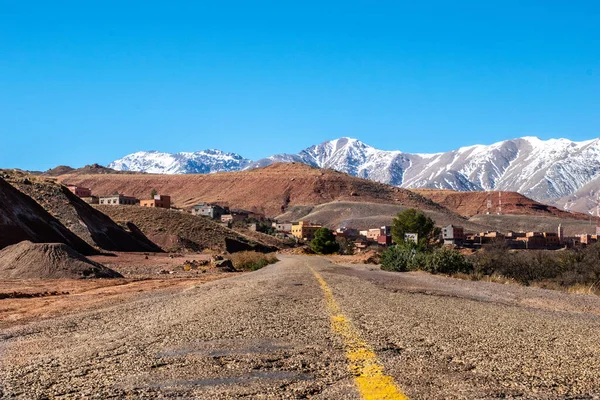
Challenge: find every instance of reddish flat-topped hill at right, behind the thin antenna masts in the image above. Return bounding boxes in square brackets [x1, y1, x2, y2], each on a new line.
[411, 189, 589, 220]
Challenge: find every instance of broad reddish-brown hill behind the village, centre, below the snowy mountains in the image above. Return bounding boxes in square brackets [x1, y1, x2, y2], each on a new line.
[58, 163, 443, 217]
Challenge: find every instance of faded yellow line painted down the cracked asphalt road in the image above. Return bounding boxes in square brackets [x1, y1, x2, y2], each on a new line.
[309, 266, 408, 400]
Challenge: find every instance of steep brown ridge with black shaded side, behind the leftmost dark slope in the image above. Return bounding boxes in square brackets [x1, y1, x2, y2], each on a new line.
[8, 173, 161, 252]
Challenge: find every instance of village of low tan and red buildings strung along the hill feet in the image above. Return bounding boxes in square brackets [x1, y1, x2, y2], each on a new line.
[66, 185, 600, 253]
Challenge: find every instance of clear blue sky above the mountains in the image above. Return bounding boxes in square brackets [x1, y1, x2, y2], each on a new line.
[0, 0, 600, 170]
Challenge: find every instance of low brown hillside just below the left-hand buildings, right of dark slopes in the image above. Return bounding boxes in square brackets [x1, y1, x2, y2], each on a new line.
[95, 206, 277, 253]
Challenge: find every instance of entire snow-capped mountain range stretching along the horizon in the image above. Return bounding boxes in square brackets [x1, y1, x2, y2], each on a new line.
[109, 137, 600, 214]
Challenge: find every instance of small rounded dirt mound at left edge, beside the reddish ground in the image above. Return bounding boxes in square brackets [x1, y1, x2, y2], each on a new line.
[0, 241, 122, 279]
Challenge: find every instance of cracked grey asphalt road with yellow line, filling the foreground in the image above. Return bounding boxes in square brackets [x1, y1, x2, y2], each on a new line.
[0, 256, 600, 399]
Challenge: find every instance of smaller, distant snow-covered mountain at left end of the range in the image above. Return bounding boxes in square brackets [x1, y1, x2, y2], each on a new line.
[108, 150, 251, 174]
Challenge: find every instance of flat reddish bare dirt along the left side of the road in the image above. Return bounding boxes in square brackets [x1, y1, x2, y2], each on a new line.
[0, 253, 239, 330]
